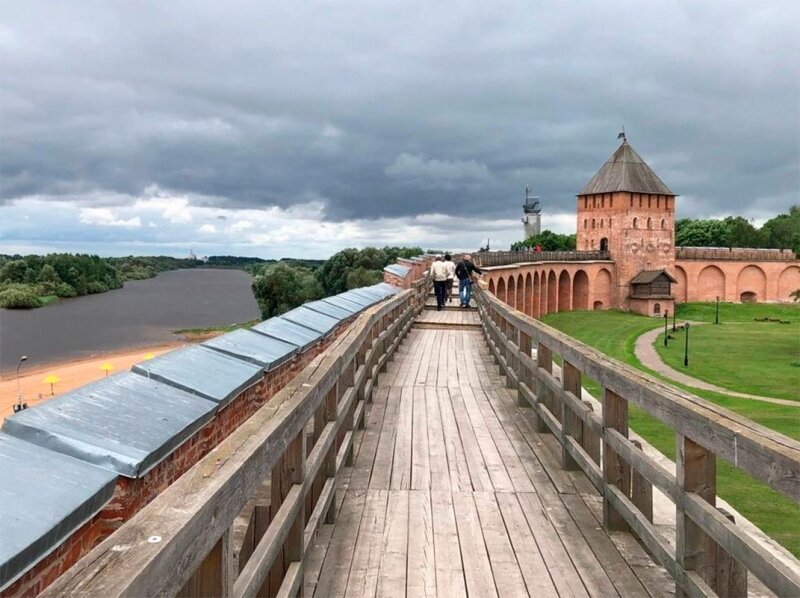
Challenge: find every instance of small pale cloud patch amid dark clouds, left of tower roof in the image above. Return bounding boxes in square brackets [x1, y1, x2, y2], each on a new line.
[384, 153, 492, 189]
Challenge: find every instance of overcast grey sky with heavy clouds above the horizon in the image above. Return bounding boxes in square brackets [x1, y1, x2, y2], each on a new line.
[0, 0, 800, 257]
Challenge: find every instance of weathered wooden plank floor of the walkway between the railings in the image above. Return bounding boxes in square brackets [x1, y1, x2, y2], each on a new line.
[304, 310, 674, 598]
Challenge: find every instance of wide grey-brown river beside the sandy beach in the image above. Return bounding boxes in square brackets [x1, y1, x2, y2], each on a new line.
[0, 268, 259, 372]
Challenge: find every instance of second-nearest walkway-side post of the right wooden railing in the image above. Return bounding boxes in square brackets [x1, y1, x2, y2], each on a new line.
[603, 388, 631, 531]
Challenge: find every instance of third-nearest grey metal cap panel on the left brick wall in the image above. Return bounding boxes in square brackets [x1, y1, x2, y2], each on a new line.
[131, 345, 263, 407]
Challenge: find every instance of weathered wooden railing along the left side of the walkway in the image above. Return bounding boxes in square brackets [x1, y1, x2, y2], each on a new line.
[43, 280, 428, 597]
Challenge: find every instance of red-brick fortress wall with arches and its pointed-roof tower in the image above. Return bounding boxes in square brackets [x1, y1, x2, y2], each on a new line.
[487, 134, 800, 317]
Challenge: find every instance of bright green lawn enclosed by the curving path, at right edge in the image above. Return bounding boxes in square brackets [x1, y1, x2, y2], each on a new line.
[656, 320, 800, 400]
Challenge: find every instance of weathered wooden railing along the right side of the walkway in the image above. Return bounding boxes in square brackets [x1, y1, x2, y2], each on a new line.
[476, 290, 800, 596]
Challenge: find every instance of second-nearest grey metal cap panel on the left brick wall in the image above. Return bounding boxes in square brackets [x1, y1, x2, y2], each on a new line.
[3, 372, 217, 478]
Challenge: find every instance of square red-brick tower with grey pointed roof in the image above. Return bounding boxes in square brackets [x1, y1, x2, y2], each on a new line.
[577, 135, 676, 311]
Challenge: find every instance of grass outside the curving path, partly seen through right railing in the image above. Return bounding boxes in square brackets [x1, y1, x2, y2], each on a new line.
[542, 304, 800, 557]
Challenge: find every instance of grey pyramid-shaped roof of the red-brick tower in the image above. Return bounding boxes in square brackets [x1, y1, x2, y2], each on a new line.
[578, 141, 675, 195]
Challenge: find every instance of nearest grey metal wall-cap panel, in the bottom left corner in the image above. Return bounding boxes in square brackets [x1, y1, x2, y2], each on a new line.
[0, 434, 117, 590]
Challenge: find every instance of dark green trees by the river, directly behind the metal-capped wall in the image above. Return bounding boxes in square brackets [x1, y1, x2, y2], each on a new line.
[252, 247, 425, 320]
